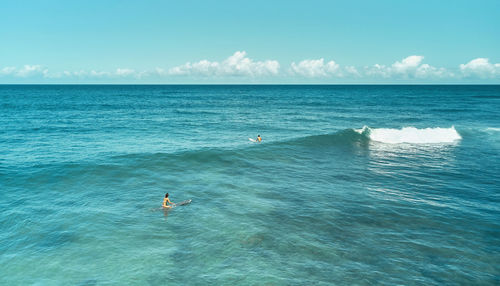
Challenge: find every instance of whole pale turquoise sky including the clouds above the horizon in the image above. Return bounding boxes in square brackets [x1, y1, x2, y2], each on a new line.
[0, 0, 500, 84]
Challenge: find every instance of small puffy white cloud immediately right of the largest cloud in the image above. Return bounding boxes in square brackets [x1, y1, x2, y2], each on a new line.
[290, 58, 341, 77]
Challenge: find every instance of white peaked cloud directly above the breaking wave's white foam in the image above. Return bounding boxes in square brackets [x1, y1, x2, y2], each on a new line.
[365, 55, 454, 79]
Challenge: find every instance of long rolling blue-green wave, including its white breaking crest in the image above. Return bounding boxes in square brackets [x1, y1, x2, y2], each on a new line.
[2, 126, 462, 180]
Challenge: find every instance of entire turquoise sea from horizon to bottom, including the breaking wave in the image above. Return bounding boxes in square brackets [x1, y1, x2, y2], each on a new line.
[0, 85, 500, 285]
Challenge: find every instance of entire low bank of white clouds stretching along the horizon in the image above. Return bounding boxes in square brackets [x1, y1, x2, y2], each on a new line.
[0, 51, 500, 81]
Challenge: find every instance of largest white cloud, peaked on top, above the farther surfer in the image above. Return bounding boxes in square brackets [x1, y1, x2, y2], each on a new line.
[168, 51, 280, 77]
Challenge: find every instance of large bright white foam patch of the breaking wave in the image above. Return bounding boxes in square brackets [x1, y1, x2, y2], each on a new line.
[355, 126, 462, 144]
